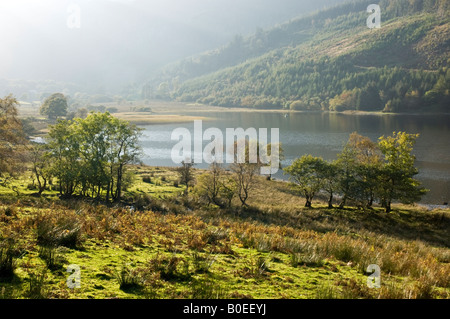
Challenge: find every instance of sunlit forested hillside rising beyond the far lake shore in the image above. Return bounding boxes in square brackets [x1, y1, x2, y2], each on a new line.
[152, 0, 450, 112]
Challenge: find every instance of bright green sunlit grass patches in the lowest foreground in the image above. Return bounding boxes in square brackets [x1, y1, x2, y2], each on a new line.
[0, 232, 370, 298]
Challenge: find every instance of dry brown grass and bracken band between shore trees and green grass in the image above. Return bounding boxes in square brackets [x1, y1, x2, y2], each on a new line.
[0, 168, 450, 298]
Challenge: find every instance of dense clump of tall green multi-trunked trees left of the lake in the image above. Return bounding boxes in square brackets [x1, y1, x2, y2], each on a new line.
[42, 112, 140, 201]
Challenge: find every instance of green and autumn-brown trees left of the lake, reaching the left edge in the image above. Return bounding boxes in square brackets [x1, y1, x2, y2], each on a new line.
[0, 96, 141, 201]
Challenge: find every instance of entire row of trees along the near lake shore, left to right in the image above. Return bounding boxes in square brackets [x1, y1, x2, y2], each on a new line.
[0, 96, 428, 212]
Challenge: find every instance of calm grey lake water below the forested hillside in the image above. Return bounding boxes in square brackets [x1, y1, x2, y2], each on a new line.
[141, 112, 450, 205]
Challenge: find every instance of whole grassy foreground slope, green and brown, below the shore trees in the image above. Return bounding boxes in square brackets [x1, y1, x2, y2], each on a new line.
[0, 166, 450, 299]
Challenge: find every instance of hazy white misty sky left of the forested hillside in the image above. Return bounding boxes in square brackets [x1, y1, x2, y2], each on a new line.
[0, 0, 342, 92]
